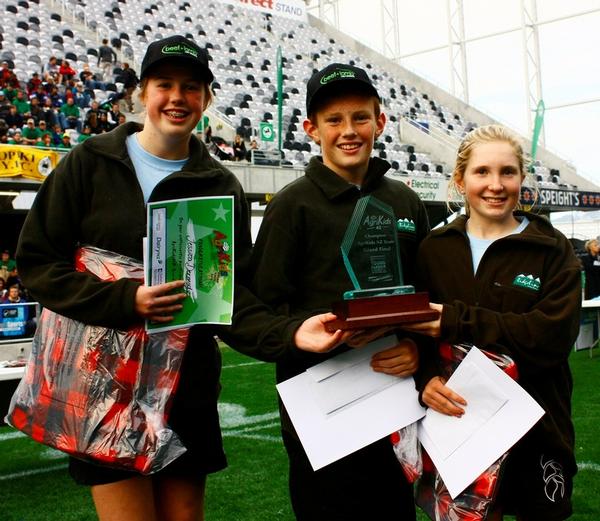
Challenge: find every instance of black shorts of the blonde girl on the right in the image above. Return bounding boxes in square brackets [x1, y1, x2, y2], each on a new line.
[498, 438, 573, 521]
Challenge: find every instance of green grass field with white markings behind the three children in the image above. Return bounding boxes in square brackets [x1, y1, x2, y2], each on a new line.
[0, 348, 600, 521]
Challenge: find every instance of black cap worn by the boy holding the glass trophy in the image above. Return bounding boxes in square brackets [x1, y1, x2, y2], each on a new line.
[306, 63, 379, 114]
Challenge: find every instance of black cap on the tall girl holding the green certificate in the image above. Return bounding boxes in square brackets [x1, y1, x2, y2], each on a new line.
[140, 35, 215, 83]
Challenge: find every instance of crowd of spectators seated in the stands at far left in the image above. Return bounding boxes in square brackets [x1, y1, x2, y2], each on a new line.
[0, 51, 138, 149]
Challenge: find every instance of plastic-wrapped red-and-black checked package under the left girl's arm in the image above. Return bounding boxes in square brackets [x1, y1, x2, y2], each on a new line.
[6, 247, 189, 474]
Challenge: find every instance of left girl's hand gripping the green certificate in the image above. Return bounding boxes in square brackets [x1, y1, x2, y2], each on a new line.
[135, 280, 185, 322]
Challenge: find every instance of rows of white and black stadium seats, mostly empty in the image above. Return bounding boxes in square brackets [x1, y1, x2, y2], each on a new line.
[0, 0, 561, 187]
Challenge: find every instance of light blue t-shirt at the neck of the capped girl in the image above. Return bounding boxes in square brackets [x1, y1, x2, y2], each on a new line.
[126, 132, 188, 203]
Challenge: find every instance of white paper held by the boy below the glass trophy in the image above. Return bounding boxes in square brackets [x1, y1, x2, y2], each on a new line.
[277, 336, 425, 470]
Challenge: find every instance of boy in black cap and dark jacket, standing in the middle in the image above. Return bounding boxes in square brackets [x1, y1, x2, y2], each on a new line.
[248, 63, 429, 521]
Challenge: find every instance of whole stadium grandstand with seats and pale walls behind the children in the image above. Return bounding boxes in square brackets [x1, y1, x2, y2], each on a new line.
[0, 0, 600, 221]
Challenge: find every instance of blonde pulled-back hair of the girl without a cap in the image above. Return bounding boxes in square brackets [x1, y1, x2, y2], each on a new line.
[448, 125, 537, 214]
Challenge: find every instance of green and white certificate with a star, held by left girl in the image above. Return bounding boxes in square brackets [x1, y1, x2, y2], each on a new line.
[146, 196, 234, 333]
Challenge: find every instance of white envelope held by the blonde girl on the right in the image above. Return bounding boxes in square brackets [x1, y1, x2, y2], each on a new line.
[419, 347, 544, 498]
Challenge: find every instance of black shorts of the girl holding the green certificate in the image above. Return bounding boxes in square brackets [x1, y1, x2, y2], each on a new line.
[69, 339, 227, 485]
